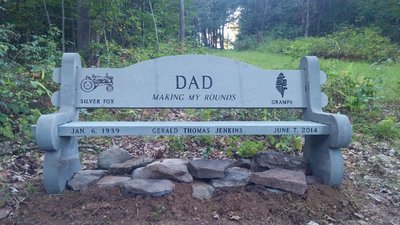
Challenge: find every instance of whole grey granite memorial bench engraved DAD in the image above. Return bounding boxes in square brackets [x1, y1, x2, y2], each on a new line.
[33, 53, 352, 194]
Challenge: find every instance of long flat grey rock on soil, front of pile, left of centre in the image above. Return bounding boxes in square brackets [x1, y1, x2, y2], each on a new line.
[119, 179, 175, 197]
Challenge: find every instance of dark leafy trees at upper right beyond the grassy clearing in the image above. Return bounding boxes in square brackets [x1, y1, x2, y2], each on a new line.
[238, 0, 400, 42]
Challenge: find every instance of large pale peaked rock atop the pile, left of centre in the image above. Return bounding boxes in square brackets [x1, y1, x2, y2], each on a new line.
[132, 159, 193, 183]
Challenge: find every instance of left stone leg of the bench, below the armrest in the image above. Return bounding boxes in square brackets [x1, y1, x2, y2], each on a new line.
[43, 137, 81, 194]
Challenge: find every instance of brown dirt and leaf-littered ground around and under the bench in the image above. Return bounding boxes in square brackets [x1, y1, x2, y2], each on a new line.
[0, 108, 400, 225]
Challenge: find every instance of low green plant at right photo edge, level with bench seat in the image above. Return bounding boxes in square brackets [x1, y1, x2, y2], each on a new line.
[372, 117, 400, 141]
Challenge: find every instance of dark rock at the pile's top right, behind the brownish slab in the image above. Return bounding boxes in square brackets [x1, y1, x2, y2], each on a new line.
[254, 151, 308, 173]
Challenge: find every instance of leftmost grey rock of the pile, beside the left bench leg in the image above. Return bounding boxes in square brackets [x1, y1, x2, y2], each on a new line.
[68, 170, 107, 191]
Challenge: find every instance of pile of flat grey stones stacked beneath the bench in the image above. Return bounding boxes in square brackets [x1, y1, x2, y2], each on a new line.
[68, 148, 308, 199]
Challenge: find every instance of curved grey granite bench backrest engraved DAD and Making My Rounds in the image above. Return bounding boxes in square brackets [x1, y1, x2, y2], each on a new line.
[52, 55, 327, 109]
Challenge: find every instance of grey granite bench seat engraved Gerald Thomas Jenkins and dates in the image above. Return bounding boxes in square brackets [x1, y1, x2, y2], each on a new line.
[58, 121, 329, 137]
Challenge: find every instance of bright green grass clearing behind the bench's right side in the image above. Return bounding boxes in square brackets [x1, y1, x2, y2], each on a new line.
[211, 49, 400, 102]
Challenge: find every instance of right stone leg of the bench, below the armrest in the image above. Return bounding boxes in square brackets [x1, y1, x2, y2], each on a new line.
[304, 136, 344, 186]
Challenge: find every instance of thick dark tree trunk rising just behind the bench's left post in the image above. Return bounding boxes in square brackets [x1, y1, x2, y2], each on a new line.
[76, 0, 90, 51]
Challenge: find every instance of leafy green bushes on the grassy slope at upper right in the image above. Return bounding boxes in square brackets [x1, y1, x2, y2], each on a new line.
[265, 27, 400, 63]
